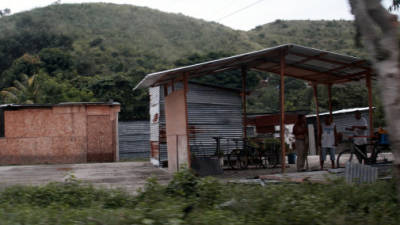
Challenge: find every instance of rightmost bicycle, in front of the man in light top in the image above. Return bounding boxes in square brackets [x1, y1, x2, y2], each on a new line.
[336, 136, 389, 168]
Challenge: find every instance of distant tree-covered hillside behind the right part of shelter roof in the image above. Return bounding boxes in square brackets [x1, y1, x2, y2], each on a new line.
[248, 20, 366, 57]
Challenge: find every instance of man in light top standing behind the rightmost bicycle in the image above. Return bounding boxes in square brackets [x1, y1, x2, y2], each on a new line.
[346, 111, 368, 163]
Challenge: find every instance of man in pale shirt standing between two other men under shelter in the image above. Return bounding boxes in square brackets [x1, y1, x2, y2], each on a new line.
[320, 116, 337, 170]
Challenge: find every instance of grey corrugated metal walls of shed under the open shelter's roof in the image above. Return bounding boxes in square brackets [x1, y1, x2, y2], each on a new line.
[150, 83, 242, 162]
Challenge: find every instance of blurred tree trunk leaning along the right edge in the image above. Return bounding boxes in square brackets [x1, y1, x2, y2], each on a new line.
[349, 0, 400, 201]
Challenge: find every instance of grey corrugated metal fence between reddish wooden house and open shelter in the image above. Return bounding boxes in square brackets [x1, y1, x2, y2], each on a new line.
[118, 120, 150, 159]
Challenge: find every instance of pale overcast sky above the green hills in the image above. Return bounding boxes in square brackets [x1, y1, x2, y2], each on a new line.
[0, 0, 392, 30]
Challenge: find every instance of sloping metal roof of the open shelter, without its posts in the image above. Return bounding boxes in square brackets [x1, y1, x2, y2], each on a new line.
[134, 44, 374, 90]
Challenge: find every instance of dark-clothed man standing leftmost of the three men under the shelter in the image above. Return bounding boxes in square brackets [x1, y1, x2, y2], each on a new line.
[293, 115, 308, 172]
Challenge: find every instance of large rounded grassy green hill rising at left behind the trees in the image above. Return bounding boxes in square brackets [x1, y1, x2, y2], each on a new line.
[0, 3, 260, 76]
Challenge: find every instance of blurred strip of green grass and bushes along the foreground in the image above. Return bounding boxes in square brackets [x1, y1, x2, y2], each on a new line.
[0, 171, 400, 225]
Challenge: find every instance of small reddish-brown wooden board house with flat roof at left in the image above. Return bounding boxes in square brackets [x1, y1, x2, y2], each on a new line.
[0, 103, 120, 165]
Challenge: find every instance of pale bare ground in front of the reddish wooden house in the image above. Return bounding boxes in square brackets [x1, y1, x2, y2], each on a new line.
[0, 162, 172, 192]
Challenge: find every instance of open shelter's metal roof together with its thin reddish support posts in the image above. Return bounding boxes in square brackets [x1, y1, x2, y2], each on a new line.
[134, 44, 374, 172]
